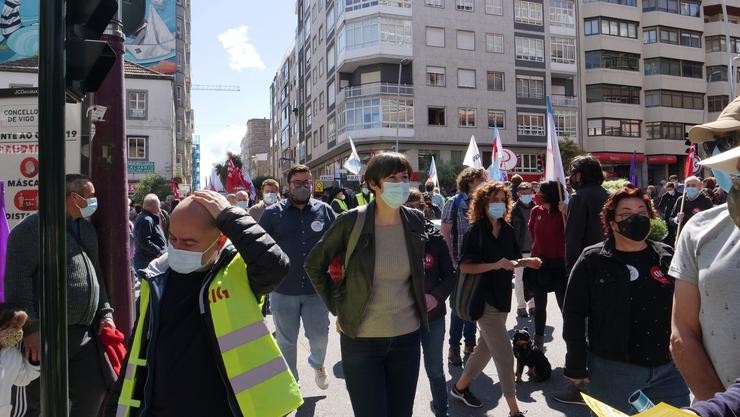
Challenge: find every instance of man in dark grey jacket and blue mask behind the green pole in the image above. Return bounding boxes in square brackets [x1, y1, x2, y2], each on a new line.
[0, 174, 112, 417]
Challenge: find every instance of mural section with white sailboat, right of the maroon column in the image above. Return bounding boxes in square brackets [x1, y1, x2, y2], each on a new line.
[122, 0, 177, 74]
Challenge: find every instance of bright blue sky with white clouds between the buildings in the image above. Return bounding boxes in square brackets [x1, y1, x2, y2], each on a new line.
[191, 0, 295, 185]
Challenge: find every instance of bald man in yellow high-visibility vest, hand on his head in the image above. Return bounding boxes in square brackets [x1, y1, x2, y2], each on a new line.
[108, 191, 302, 417]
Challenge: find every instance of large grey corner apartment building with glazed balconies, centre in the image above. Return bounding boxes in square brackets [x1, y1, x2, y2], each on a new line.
[270, 0, 581, 184]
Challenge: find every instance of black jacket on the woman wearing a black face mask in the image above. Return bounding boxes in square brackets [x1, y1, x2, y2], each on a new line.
[563, 239, 673, 379]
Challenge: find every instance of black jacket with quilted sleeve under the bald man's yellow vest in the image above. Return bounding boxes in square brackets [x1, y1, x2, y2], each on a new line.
[105, 207, 290, 417]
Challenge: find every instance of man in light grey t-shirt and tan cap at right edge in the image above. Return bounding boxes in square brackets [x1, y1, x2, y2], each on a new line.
[669, 99, 740, 400]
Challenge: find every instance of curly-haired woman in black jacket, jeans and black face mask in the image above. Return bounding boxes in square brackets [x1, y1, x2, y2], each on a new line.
[563, 188, 689, 414]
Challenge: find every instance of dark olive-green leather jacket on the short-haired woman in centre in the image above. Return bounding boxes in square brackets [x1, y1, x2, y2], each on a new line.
[304, 201, 428, 338]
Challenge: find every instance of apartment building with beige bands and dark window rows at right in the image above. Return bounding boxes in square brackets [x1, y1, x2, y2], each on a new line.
[579, 0, 740, 183]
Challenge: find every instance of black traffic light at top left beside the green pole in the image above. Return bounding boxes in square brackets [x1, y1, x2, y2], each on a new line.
[65, 0, 118, 99]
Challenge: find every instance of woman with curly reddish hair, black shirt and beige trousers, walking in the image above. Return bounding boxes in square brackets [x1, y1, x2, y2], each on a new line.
[450, 181, 541, 417]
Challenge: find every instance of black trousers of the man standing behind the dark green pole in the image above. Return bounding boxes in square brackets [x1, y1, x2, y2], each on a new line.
[11, 326, 107, 417]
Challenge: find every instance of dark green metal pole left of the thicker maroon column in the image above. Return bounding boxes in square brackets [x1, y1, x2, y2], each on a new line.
[38, 0, 69, 417]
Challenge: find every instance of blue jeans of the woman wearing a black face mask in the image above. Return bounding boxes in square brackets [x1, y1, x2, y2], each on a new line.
[588, 352, 690, 414]
